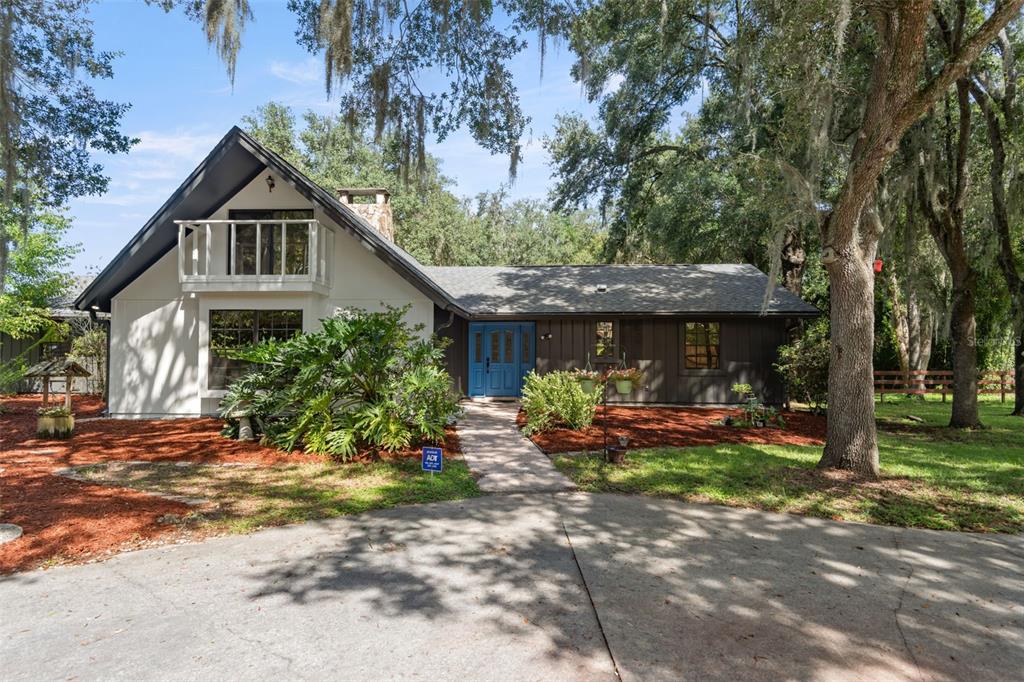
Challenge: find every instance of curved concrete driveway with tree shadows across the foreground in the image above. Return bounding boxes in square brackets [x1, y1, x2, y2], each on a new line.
[0, 494, 1024, 681]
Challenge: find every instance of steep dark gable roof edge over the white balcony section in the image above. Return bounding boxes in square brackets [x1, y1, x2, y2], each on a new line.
[75, 126, 456, 312]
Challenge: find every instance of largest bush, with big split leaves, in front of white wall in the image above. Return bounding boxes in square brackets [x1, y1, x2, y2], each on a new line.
[220, 307, 459, 460]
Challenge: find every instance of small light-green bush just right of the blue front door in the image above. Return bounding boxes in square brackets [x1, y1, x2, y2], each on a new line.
[522, 372, 601, 435]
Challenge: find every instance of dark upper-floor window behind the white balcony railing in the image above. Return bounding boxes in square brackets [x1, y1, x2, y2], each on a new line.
[227, 209, 313, 274]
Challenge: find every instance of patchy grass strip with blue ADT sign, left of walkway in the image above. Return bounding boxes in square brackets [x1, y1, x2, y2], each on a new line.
[76, 459, 480, 532]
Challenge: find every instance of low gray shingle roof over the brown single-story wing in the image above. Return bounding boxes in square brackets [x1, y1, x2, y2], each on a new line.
[423, 264, 819, 315]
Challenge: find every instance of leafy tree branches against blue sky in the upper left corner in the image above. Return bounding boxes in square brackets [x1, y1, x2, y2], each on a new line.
[0, 0, 136, 208]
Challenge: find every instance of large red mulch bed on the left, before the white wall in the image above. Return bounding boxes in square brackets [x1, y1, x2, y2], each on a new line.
[0, 395, 460, 573]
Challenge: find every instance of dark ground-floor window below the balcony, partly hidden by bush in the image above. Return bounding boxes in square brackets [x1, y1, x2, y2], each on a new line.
[207, 310, 302, 390]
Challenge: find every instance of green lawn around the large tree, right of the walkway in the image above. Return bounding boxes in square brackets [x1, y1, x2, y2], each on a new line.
[555, 396, 1024, 532]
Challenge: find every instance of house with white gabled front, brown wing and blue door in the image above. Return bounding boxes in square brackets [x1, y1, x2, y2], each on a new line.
[76, 128, 818, 417]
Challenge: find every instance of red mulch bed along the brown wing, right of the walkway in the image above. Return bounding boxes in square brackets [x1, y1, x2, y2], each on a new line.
[518, 407, 825, 453]
